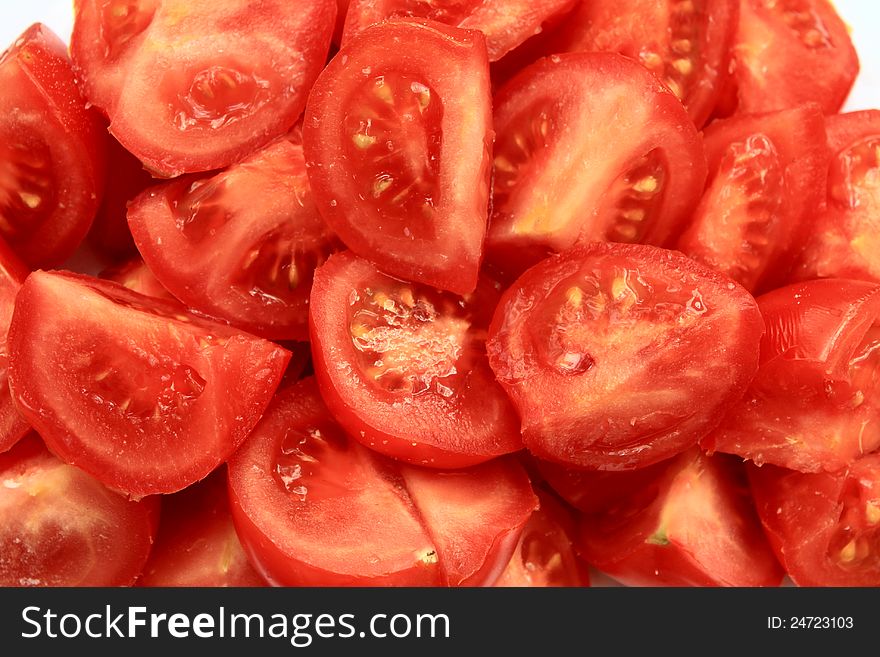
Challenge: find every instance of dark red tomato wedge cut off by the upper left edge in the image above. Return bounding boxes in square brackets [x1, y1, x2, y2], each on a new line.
[0, 23, 106, 267]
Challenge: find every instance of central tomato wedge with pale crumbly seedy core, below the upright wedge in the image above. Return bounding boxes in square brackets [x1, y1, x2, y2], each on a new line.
[310, 252, 522, 468]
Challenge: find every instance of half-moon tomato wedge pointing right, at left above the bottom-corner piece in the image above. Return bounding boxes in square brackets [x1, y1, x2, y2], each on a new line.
[9, 271, 290, 498]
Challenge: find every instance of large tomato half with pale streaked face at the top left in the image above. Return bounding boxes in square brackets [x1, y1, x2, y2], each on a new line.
[71, 0, 336, 177]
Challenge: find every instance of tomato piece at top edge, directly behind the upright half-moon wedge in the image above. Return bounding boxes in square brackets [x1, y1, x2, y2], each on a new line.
[342, 0, 575, 62]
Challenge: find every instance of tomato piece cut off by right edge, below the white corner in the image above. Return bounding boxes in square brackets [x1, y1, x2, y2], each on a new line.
[794, 110, 880, 281]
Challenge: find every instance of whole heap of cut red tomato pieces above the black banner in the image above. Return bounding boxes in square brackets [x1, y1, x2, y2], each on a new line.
[0, 0, 880, 587]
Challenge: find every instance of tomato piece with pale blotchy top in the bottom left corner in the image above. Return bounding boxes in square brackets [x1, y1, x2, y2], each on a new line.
[0, 434, 159, 586]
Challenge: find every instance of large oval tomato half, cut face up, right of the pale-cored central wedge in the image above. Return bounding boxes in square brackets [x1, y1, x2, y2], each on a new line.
[487, 243, 763, 470]
